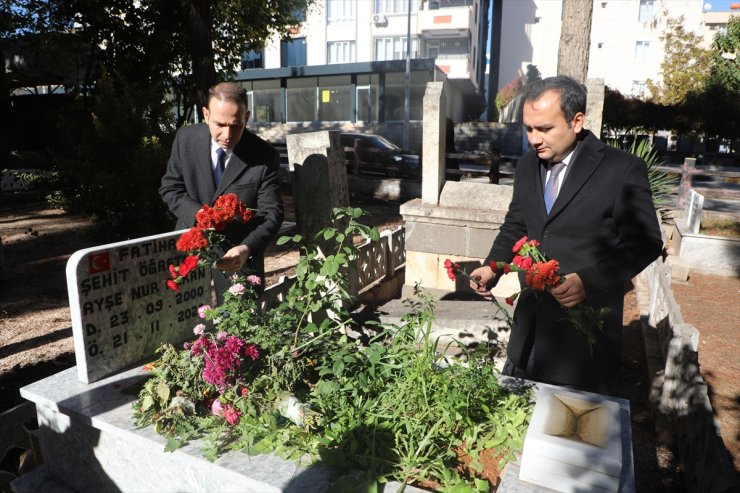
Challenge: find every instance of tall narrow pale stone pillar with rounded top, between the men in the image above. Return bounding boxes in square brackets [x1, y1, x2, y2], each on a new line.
[421, 82, 447, 205]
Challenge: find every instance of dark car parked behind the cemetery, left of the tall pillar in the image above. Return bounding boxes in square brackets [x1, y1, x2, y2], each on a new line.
[340, 133, 421, 179]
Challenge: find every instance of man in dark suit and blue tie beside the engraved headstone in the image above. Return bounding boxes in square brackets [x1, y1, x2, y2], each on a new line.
[159, 82, 283, 301]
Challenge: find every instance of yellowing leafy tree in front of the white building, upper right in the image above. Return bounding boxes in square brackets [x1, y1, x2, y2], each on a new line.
[647, 16, 712, 105]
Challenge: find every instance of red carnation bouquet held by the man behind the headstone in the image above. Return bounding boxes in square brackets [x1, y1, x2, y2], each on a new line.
[167, 193, 254, 291]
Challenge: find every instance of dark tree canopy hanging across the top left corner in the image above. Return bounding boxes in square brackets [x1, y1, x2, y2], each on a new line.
[6, 0, 314, 124]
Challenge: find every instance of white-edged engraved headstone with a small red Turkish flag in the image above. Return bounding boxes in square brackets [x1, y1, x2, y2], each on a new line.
[67, 231, 211, 383]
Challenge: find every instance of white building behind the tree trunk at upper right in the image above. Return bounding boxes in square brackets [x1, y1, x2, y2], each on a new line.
[498, 0, 740, 96]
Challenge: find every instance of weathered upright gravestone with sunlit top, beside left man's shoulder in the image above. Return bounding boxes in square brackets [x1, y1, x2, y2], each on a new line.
[286, 130, 349, 238]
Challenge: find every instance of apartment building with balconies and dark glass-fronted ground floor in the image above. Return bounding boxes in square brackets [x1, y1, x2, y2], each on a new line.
[237, 0, 488, 123]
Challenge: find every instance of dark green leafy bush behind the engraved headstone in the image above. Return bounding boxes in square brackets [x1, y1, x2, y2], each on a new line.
[38, 70, 174, 238]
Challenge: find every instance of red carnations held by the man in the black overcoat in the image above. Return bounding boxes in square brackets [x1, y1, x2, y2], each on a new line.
[444, 236, 609, 349]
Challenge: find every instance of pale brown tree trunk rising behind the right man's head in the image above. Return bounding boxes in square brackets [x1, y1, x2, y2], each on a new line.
[558, 0, 594, 84]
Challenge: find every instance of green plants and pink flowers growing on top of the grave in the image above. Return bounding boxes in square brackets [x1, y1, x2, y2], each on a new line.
[134, 208, 530, 492]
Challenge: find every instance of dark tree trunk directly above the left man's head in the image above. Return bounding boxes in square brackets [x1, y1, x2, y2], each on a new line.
[188, 0, 216, 116]
